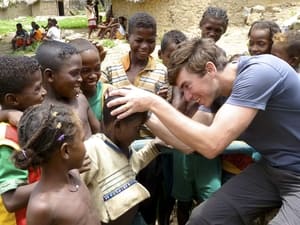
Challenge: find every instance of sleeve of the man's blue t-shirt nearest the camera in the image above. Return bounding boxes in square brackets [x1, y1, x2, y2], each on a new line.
[226, 63, 283, 110]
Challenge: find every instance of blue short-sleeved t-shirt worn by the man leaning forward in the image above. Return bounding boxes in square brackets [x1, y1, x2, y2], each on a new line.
[226, 55, 300, 173]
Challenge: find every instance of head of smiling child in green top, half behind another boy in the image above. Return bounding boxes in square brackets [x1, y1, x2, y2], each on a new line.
[70, 38, 101, 97]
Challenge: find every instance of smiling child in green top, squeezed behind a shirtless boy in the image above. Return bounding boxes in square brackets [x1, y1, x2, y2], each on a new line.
[70, 38, 112, 121]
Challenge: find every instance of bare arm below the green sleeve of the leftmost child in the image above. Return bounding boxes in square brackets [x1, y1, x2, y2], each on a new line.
[1, 183, 36, 212]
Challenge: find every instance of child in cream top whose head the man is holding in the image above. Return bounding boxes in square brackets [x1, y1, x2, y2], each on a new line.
[82, 94, 159, 225]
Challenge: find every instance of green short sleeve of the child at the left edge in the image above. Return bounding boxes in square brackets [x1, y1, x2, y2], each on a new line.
[0, 145, 28, 194]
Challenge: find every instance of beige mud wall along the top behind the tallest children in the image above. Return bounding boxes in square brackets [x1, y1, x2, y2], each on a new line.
[112, 0, 292, 36]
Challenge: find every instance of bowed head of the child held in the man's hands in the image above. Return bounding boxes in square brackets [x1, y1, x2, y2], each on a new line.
[102, 96, 148, 147]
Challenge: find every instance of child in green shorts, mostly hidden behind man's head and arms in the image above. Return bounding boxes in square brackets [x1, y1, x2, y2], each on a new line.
[159, 30, 221, 225]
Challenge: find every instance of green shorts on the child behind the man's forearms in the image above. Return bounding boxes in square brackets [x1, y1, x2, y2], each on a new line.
[172, 151, 222, 201]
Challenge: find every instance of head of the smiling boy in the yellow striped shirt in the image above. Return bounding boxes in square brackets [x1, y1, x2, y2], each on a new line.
[128, 13, 156, 61]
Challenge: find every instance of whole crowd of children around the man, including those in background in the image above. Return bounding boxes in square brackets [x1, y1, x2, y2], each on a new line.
[0, 1, 300, 225]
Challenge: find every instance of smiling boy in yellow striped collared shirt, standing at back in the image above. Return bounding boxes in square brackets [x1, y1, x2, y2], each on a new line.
[100, 12, 171, 224]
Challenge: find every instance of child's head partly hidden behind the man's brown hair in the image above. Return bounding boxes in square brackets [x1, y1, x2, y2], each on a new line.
[158, 30, 187, 66]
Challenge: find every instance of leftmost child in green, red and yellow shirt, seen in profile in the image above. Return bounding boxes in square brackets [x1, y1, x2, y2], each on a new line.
[0, 56, 46, 225]
